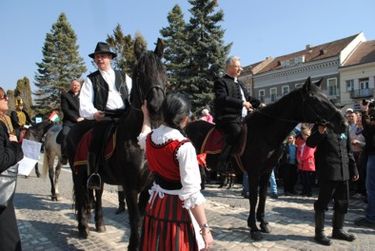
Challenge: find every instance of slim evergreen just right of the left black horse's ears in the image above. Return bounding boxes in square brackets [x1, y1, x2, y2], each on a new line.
[160, 5, 188, 91]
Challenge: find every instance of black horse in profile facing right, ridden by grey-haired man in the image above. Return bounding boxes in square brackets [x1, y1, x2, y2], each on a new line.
[186, 78, 346, 240]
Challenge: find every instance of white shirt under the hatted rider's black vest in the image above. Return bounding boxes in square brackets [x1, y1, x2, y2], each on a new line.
[79, 68, 132, 119]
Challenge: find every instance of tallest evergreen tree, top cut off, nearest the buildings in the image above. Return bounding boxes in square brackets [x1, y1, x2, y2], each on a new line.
[184, 0, 232, 111]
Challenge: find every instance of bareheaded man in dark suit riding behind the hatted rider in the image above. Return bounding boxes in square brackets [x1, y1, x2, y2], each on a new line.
[61, 79, 84, 165]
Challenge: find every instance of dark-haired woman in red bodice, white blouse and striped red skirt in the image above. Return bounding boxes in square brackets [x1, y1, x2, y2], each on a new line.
[138, 94, 213, 251]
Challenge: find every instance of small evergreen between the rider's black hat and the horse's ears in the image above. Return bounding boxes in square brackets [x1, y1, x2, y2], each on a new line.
[106, 24, 135, 77]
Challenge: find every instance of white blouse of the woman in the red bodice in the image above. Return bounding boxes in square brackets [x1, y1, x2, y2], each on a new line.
[138, 125, 206, 209]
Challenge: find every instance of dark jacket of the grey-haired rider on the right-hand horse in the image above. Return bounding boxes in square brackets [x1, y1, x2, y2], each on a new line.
[214, 75, 260, 123]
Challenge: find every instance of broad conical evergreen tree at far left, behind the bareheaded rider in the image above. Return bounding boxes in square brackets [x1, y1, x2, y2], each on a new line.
[34, 13, 86, 114]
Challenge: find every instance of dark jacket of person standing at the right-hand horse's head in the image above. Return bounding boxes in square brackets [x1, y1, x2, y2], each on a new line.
[306, 125, 358, 181]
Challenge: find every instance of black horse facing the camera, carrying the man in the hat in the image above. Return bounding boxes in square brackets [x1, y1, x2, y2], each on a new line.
[68, 39, 167, 250]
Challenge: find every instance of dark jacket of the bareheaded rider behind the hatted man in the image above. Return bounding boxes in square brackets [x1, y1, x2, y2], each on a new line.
[61, 91, 80, 125]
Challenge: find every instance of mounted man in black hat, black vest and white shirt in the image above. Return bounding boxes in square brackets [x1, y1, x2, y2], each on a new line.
[67, 42, 132, 188]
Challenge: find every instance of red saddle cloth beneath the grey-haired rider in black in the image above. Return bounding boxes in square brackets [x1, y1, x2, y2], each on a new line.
[198, 124, 247, 171]
